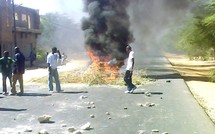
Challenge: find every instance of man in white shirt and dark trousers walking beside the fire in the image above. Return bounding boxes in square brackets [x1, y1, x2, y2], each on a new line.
[124, 46, 137, 93]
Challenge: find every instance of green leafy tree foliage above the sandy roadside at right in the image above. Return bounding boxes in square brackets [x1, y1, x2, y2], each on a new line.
[177, 0, 215, 82]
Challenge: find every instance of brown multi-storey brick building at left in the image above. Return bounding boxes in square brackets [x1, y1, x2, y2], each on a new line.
[0, 0, 41, 57]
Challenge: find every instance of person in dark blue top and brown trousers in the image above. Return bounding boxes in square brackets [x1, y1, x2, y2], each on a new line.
[11, 47, 25, 95]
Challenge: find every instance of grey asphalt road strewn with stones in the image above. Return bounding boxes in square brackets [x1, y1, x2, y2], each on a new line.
[0, 57, 215, 134]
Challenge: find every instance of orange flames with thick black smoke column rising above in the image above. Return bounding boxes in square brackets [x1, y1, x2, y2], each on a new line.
[82, 0, 133, 79]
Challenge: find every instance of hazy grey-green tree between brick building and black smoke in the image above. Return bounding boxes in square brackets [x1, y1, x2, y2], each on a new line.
[37, 13, 84, 58]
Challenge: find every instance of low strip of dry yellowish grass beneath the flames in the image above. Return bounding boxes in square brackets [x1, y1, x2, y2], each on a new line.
[32, 69, 152, 85]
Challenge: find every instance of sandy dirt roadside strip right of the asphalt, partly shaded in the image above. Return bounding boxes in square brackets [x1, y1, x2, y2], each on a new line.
[165, 53, 215, 123]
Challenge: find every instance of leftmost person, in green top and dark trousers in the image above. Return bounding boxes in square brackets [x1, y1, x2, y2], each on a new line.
[0, 51, 15, 95]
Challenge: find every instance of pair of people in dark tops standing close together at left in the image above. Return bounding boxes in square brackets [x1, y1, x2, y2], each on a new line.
[0, 47, 25, 95]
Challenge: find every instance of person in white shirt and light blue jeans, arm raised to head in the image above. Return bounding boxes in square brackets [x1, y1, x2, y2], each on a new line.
[47, 47, 62, 92]
